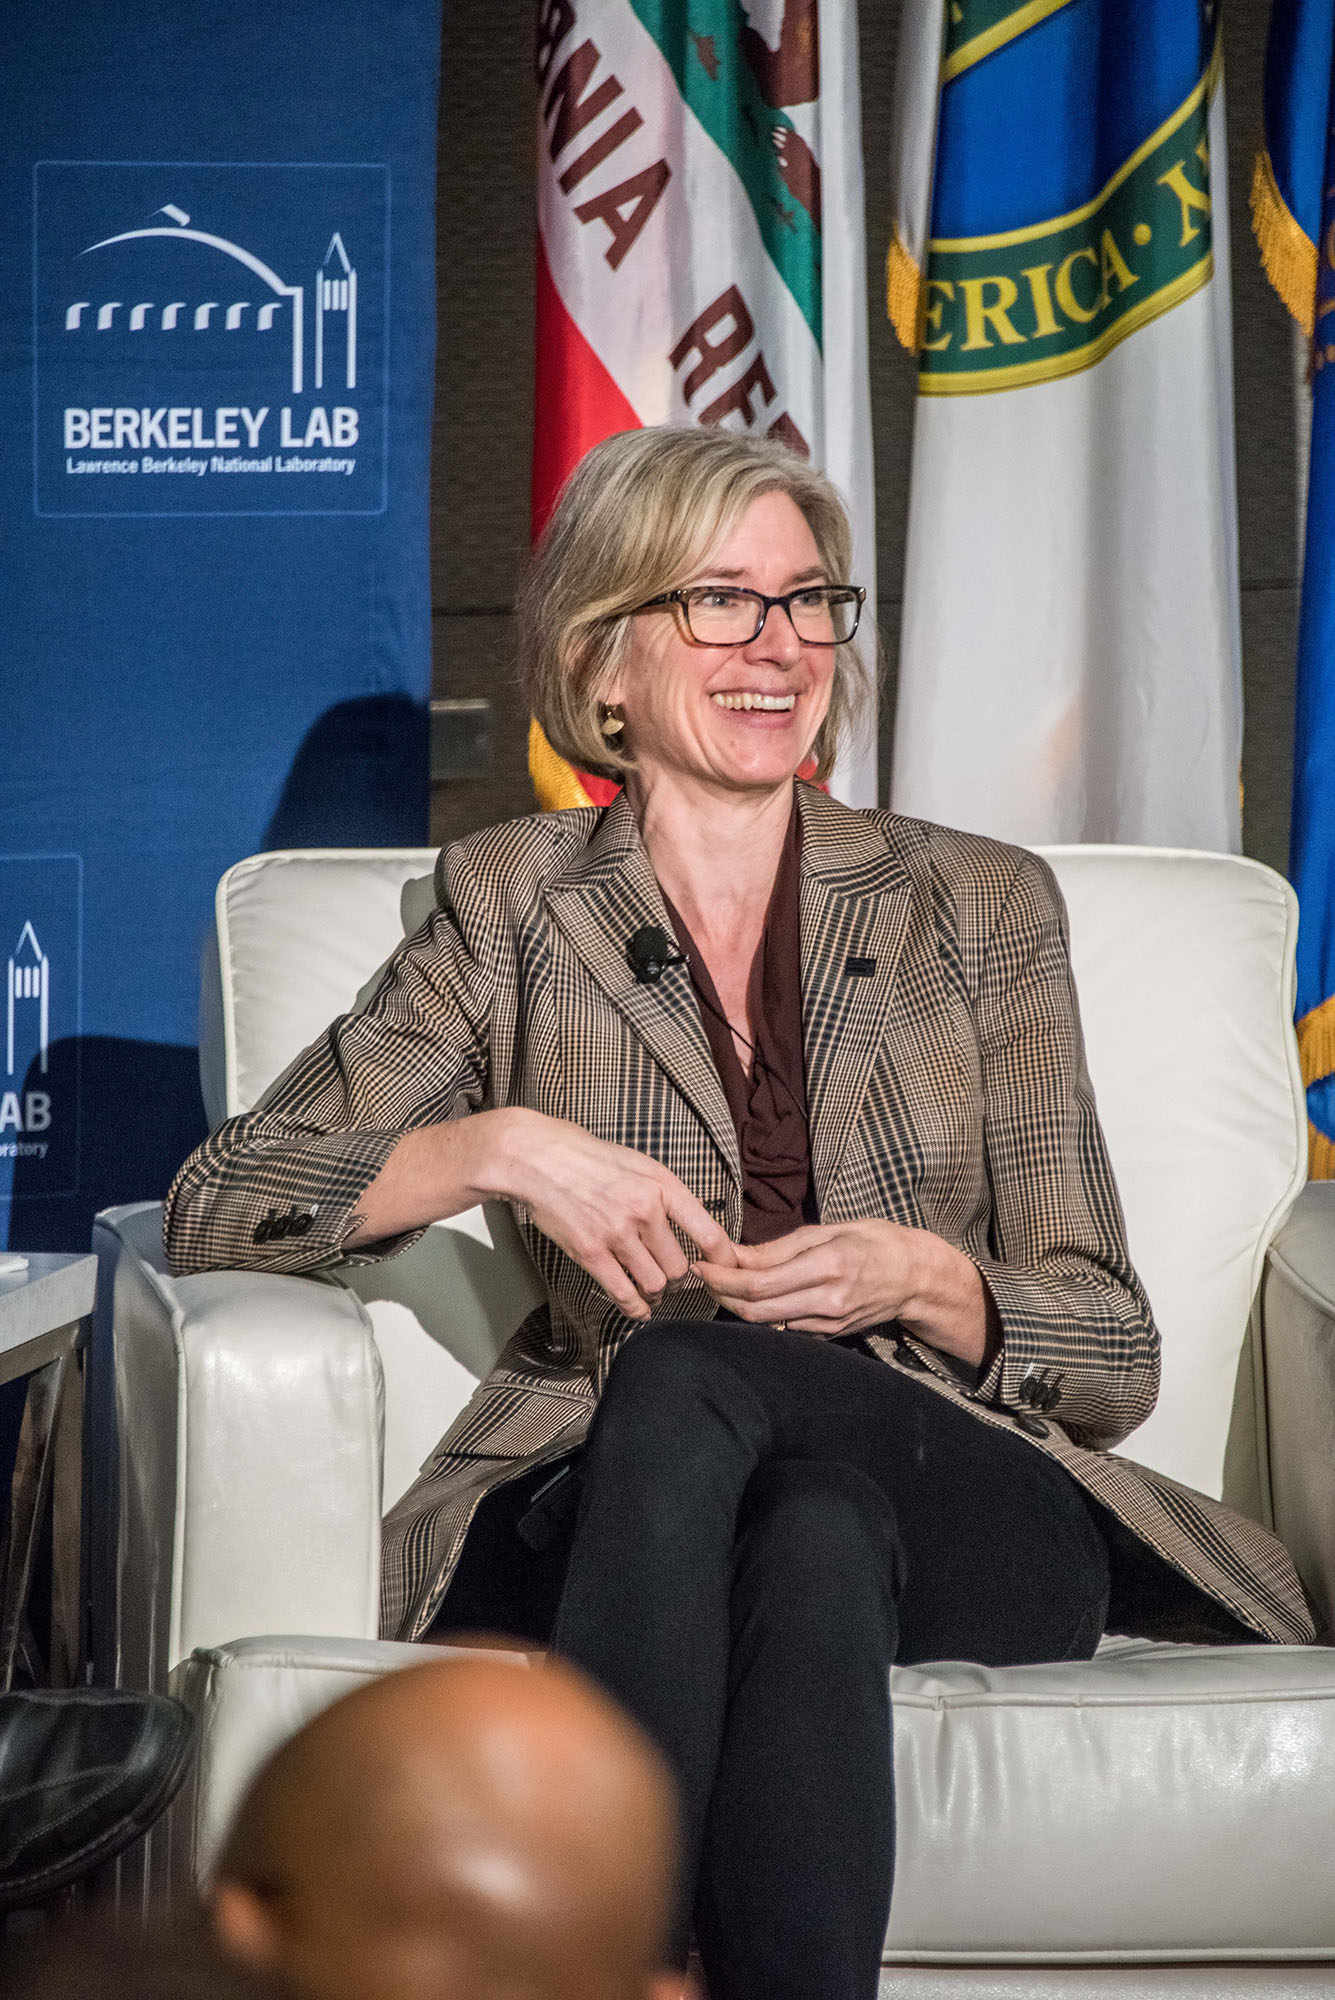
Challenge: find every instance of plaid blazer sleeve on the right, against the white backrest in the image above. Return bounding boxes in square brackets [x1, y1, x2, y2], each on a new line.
[975, 854, 1159, 1450]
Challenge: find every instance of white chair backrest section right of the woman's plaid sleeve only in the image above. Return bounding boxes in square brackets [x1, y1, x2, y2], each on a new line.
[1041, 846, 1307, 1496]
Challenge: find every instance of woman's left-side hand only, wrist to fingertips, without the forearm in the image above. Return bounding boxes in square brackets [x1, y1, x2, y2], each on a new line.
[484, 1108, 737, 1320]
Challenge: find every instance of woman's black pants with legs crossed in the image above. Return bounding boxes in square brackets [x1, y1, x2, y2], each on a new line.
[438, 1320, 1109, 2000]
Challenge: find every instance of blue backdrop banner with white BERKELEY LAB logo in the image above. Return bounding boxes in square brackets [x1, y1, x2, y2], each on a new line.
[0, 0, 440, 1248]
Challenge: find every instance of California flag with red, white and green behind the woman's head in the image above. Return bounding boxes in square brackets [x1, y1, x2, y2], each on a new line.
[530, 0, 875, 808]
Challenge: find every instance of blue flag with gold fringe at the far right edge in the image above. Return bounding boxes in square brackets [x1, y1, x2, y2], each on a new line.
[1251, 0, 1335, 1180]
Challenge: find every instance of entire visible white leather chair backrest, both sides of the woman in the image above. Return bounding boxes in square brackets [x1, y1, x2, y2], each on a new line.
[202, 846, 1307, 1504]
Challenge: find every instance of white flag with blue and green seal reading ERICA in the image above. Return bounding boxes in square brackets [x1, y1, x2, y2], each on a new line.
[889, 0, 1241, 850]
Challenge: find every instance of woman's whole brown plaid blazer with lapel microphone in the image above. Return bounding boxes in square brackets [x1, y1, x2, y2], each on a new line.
[166, 786, 1313, 1640]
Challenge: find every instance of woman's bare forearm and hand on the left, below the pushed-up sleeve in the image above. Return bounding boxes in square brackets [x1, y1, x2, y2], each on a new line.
[344, 1106, 737, 1320]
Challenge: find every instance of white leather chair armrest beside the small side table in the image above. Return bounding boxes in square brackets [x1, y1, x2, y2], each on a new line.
[94, 1202, 382, 1688]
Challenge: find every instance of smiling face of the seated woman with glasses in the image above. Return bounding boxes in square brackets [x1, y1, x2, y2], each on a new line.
[608, 492, 843, 792]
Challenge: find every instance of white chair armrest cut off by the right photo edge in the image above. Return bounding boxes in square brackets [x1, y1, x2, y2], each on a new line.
[1261, 1180, 1335, 1636]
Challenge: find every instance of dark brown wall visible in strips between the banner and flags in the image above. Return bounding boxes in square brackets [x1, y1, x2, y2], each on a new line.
[432, 0, 1297, 868]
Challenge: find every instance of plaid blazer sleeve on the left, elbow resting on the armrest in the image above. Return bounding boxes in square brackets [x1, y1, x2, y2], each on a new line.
[164, 880, 494, 1272]
